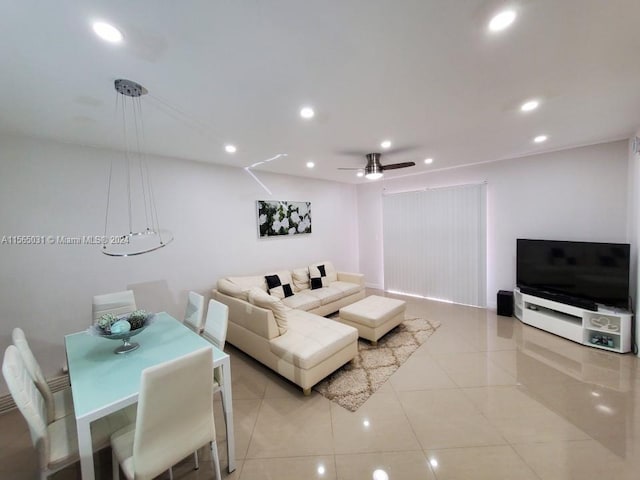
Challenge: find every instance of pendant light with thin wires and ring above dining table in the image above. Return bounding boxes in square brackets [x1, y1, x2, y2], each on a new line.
[102, 79, 173, 257]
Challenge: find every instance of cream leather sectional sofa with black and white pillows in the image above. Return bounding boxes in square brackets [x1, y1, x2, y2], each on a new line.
[213, 261, 365, 395]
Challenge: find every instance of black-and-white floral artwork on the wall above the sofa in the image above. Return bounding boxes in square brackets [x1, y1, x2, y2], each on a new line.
[256, 200, 311, 238]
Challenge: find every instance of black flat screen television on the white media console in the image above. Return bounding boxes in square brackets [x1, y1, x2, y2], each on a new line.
[516, 238, 630, 309]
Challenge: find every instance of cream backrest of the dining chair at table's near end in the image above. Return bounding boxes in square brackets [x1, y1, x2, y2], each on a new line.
[133, 347, 216, 479]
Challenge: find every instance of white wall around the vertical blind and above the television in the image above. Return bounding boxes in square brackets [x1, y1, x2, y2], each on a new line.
[358, 141, 628, 307]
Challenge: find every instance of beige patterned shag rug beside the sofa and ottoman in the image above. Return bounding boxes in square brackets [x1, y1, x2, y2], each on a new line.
[313, 318, 440, 412]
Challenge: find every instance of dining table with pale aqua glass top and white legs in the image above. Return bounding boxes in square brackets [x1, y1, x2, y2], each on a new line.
[65, 312, 235, 480]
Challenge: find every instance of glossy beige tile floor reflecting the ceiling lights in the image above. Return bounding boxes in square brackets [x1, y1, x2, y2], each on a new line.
[0, 292, 640, 480]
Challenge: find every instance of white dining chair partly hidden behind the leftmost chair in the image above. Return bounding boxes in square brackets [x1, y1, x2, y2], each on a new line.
[11, 327, 73, 423]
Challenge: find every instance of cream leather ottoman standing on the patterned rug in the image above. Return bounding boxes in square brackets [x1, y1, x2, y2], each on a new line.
[337, 295, 406, 345]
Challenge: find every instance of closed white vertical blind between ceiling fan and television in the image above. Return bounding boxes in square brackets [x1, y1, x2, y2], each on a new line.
[382, 184, 487, 306]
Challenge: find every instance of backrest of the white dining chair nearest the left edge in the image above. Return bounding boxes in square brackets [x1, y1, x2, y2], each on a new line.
[2, 345, 48, 470]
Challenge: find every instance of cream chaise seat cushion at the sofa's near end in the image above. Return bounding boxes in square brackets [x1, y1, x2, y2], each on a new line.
[270, 310, 358, 369]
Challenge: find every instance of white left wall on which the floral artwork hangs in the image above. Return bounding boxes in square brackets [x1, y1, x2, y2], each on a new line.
[0, 136, 358, 394]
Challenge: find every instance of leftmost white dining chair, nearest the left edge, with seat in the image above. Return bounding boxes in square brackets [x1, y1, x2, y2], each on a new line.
[2, 345, 135, 480]
